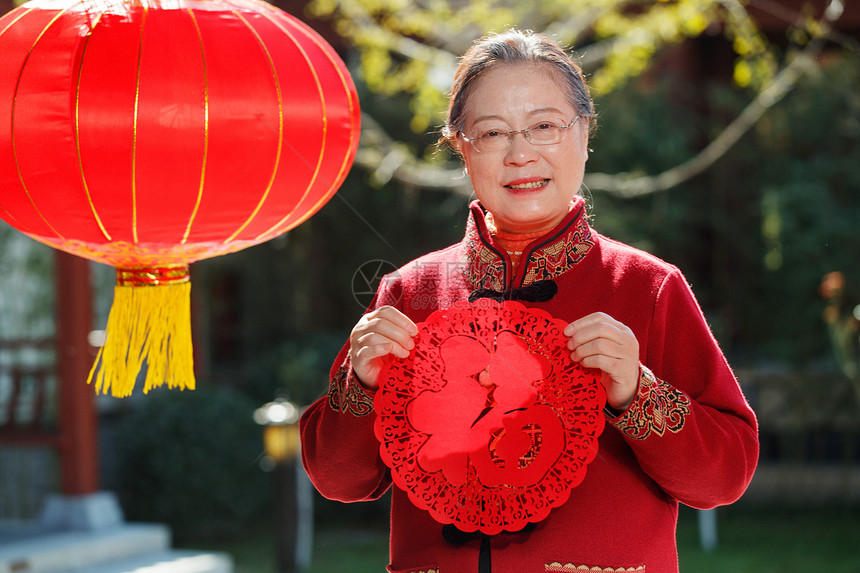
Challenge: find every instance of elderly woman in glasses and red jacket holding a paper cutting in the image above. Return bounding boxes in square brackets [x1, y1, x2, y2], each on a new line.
[301, 27, 758, 573]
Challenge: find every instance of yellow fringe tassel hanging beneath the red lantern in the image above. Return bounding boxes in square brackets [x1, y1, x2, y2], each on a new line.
[87, 267, 195, 398]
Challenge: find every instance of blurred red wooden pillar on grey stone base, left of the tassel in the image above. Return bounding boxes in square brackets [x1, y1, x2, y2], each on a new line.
[54, 251, 99, 495]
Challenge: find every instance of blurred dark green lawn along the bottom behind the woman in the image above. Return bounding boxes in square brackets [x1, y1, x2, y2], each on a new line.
[197, 507, 860, 573]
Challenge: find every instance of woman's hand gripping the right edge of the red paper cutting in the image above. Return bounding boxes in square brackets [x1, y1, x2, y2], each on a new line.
[564, 312, 639, 411]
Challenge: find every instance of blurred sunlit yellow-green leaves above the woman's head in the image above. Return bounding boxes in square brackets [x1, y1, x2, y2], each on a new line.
[307, 0, 788, 132]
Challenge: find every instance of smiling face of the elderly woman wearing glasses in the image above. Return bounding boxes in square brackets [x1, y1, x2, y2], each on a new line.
[458, 64, 588, 233]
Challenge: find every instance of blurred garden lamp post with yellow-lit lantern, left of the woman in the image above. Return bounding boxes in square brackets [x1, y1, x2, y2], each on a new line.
[254, 398, 313, 573]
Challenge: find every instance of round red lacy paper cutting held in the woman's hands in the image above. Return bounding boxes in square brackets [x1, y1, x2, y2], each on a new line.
[374, 299, 606, 535]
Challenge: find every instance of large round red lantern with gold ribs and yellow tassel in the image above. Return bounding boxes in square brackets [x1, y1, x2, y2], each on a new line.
[0, 0, 359, 396]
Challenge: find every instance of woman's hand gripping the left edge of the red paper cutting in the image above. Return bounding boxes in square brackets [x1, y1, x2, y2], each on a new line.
[349, 306, 418, 389]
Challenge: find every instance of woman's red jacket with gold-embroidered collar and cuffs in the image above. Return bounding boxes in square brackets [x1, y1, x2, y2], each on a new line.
[301, 200, 758, 573]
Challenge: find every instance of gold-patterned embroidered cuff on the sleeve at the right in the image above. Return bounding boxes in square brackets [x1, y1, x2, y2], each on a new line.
[606, 365, 690, 440]
